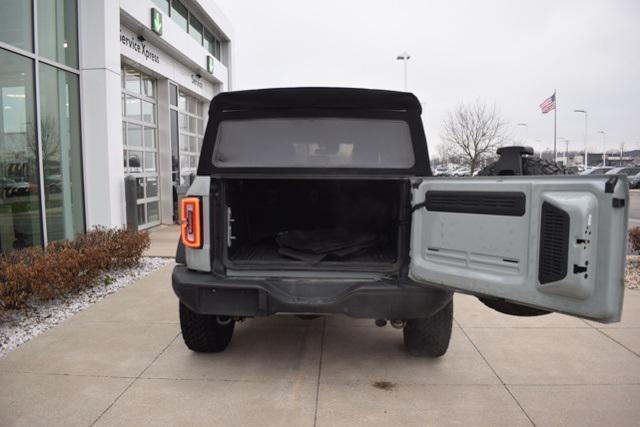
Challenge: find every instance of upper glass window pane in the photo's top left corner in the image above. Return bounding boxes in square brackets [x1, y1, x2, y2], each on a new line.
[0, 0, 33, 52]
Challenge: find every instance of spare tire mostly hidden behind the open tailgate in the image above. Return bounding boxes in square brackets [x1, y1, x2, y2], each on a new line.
[478, 157, 572, 316]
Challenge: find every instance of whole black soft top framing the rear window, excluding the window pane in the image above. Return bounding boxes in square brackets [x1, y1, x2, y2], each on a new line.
[198, 87, 431, 176]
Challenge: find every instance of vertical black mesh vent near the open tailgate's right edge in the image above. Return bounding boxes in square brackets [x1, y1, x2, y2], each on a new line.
[538, 202, 570, 284]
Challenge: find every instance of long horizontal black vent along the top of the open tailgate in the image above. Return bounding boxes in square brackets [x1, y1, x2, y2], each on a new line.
[424, 191, 526, 216]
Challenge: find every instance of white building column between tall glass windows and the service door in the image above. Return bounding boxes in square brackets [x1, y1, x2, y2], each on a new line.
[78, 0, 125, 229]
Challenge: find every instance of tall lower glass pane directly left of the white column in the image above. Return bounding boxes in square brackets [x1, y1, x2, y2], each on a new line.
[39, 63, 84, 241]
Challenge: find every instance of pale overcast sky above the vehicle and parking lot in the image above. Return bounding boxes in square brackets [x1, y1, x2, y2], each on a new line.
[217, 0, 640, 154]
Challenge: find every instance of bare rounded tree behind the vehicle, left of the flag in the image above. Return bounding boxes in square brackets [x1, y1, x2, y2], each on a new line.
[441, 101, 507, 174]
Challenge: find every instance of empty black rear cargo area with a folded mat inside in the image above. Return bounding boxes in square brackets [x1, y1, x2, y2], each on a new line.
[224, 179, 407, 270]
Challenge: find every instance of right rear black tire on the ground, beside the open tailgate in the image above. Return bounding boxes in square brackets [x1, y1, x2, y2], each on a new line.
[402, 300, 453, 357]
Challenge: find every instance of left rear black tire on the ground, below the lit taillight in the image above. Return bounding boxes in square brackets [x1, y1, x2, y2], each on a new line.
[180, 303, 236, 353]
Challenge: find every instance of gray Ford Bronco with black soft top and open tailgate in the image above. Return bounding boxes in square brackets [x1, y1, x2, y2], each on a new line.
[172, 88, 628, 357]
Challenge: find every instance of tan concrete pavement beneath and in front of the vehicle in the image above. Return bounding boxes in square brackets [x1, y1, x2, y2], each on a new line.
[0, 264, 640, 426]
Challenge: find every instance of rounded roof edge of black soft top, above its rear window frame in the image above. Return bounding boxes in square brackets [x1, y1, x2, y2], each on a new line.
[209, 87, 422, 114]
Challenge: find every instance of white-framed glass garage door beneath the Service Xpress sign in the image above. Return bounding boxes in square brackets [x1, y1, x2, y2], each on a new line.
[122, 65, 160, 229]
